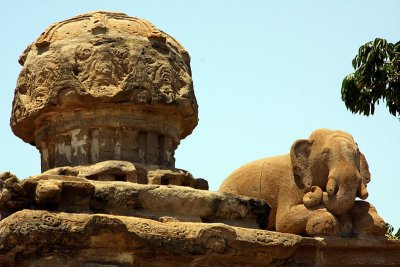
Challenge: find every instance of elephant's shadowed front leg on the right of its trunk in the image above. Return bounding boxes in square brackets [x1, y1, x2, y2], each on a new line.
[351, 201, 386, 236]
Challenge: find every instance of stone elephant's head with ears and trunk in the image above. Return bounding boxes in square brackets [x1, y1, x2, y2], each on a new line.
[290, 129, 370, 216]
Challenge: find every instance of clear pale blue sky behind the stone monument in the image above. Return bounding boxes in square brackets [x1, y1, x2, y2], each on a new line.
[0, 0, 400, 228]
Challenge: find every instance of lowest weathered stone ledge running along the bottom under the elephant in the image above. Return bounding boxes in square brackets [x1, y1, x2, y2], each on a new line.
[0, 210, 400, 267]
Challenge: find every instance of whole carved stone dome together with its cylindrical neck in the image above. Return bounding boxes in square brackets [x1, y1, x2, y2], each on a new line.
[11, 12, 198, 171]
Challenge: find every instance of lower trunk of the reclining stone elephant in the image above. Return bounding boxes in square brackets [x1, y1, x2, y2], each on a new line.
[322, 178, 357, 215]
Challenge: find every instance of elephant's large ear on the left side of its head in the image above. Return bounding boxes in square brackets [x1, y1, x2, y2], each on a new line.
[290, 139, 312, 191]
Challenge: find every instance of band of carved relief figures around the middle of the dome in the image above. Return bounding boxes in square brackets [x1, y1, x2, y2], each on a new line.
[13, 34, 193, 119]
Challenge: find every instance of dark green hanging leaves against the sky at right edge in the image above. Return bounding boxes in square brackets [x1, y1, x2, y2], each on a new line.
[342, 38, 400, 116]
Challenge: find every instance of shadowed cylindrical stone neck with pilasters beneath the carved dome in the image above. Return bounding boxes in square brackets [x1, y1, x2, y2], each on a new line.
[36, 109, 180, 172]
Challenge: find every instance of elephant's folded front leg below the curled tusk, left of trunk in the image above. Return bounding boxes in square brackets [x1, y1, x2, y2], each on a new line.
[276, 204, 339, 236]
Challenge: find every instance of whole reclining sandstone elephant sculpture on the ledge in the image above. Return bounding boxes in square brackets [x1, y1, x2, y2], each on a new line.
[219, 129, 386, 236]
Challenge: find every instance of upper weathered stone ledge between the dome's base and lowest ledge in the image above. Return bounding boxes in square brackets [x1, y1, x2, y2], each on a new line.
[0, 174, 269, 228]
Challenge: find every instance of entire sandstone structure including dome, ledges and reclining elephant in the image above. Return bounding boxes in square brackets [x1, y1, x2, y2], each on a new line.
[4, 11, 400, 267]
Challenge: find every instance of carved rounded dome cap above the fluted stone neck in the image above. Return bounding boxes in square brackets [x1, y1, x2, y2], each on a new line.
[11, 12, 197, 149]
